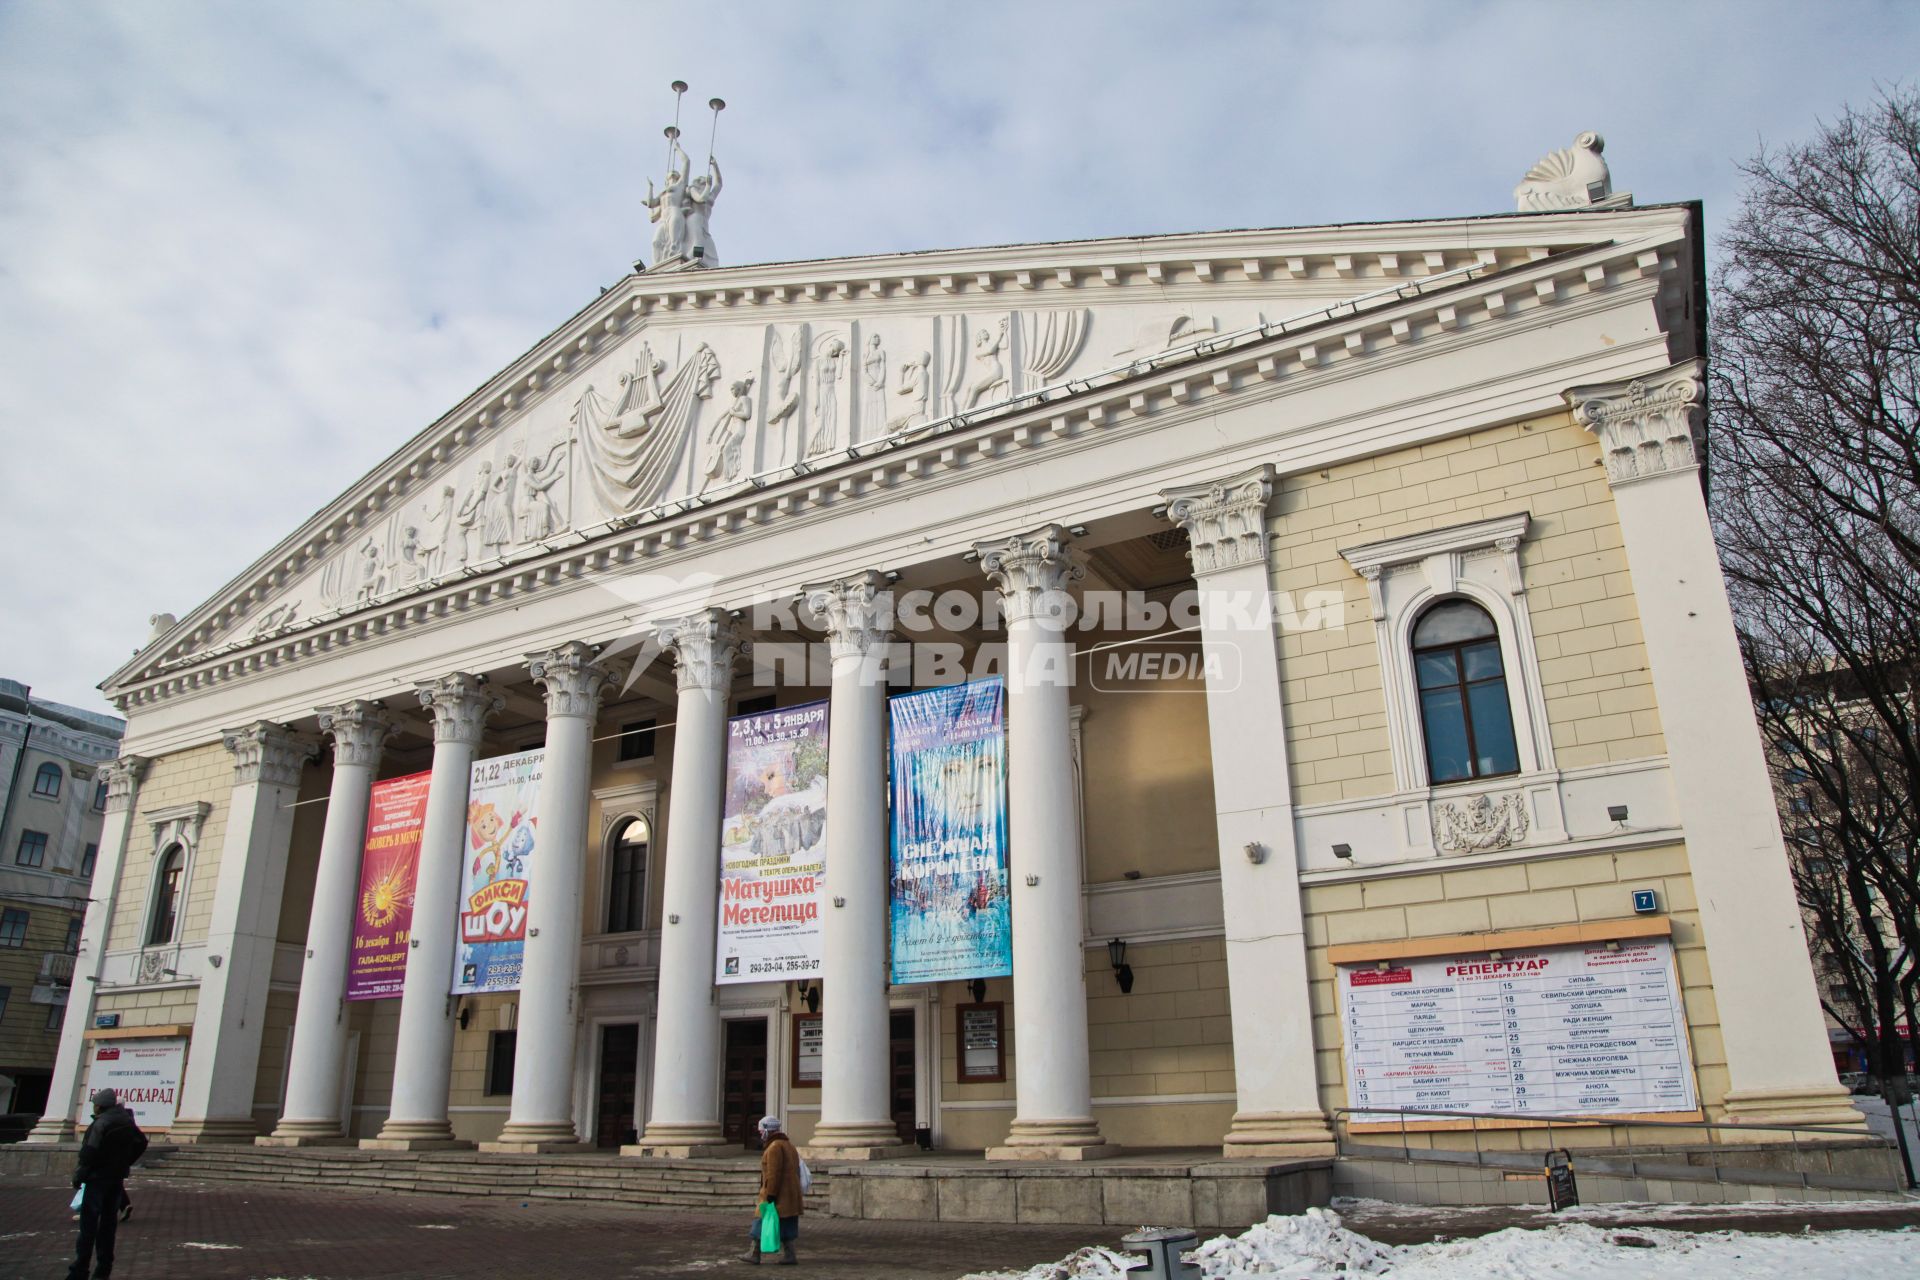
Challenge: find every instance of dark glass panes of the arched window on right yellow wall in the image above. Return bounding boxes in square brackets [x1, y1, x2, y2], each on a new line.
[1413, 599, 1521, 785]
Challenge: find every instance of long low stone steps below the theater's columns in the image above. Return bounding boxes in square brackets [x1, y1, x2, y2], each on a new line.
[142, 1144, 828, 1215]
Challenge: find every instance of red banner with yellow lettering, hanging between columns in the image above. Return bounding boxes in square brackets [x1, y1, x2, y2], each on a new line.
[348, 773, 434, 1000]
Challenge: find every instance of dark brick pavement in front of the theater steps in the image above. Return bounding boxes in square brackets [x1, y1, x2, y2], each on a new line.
[0, 1174, 1125, 1280]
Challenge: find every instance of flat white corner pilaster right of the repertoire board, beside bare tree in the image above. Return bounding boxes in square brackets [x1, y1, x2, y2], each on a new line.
[1567, 361, 1860, 1138]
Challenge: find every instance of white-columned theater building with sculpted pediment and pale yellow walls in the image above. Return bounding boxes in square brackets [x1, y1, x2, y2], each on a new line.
[35, 144, 1859, 1159]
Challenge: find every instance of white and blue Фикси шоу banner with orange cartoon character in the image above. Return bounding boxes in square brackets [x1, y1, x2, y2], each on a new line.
[453, 750, 547, 994]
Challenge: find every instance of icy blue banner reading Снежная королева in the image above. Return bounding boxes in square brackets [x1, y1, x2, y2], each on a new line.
[887, 679, 1014, 983]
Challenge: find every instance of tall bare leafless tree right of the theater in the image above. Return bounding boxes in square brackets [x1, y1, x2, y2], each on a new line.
[1711, 88, 1920, 1182]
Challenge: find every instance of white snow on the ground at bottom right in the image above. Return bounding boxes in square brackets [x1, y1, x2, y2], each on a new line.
[968, 1209, 1920, 1280]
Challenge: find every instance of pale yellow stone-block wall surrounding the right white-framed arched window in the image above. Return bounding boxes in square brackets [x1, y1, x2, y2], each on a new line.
[1269, 415, 1667, 804]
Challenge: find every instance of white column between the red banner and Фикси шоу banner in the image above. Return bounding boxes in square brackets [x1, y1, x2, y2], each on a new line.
[361, 672, 507, 1151]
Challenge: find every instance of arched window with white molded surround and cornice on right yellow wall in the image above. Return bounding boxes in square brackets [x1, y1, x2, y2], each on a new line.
[1340, 510, 1553, 791]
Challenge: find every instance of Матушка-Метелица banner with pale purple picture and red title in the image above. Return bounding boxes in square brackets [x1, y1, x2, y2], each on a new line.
[714, 702, 828, 983]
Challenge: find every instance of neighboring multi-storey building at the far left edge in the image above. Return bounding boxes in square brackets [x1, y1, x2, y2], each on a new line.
[0, 679, 127, 1115]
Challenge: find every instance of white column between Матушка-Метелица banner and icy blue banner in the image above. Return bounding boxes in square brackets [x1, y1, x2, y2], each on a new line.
[806, 570, 914, 1159]
